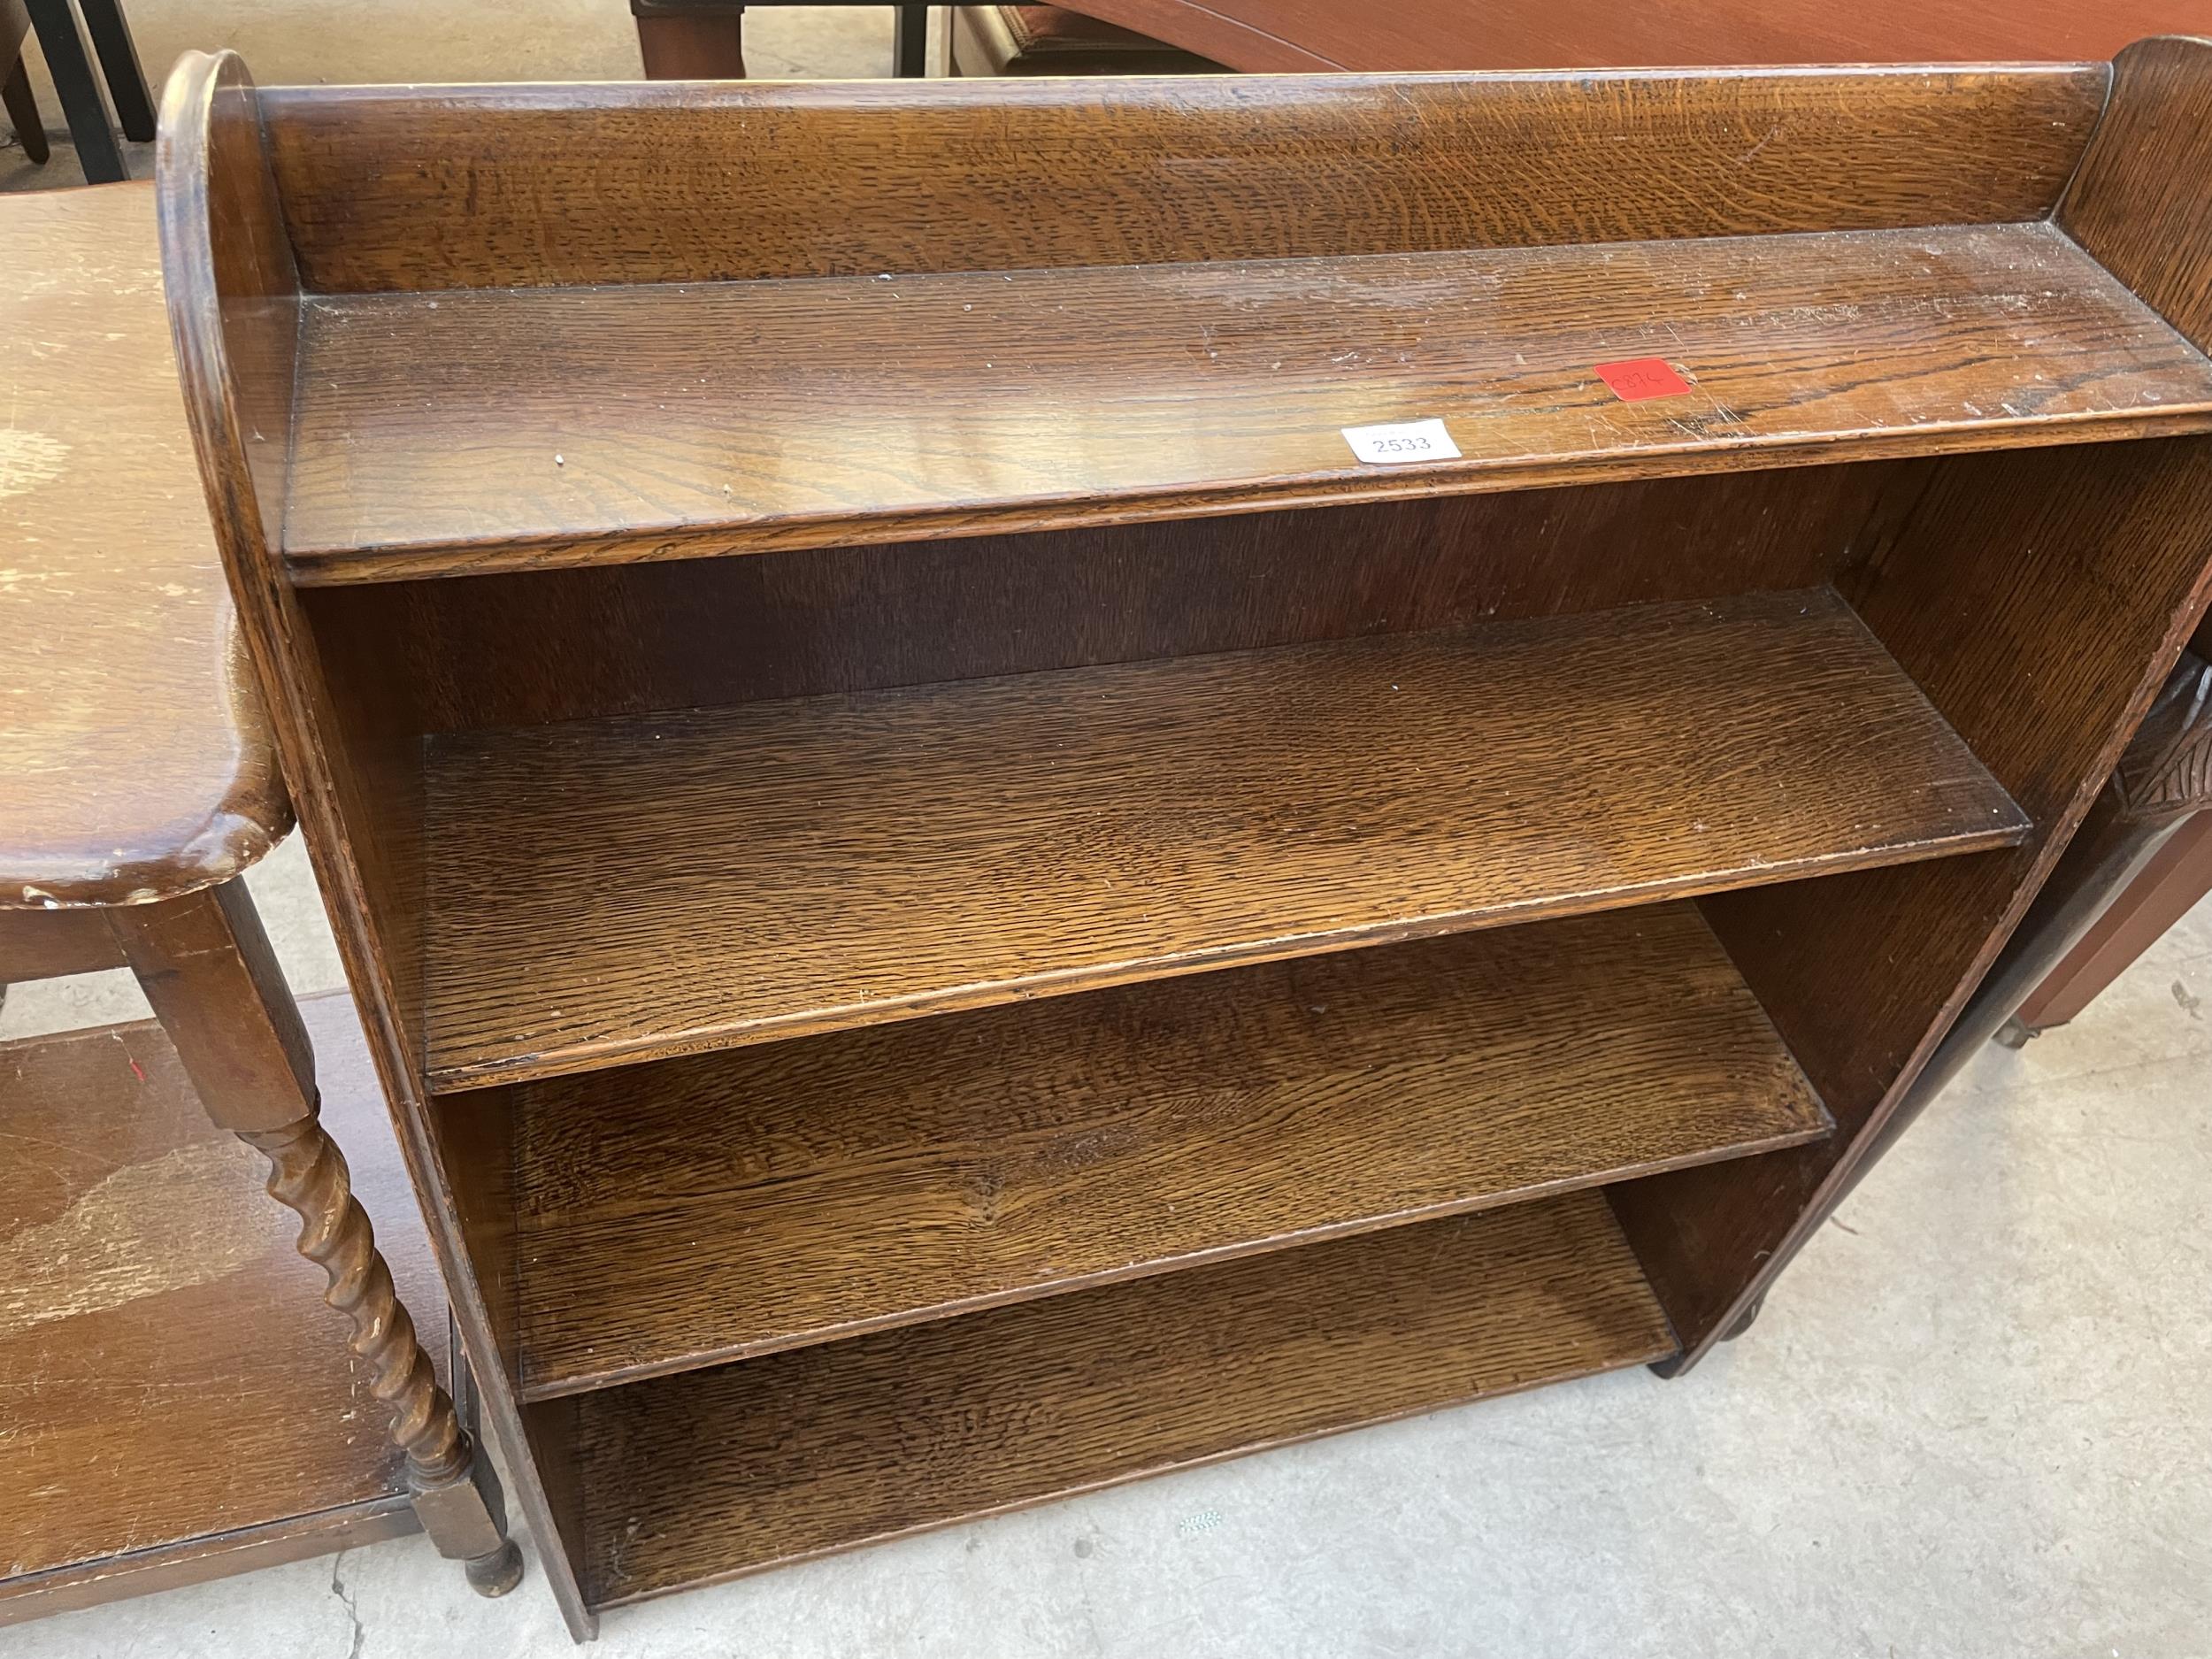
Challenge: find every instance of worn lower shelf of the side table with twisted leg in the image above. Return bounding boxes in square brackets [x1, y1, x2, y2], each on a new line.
[0, 994, 445, 1622]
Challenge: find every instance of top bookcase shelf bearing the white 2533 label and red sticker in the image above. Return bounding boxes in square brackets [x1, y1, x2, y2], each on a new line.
[286, 224, 2212, 582]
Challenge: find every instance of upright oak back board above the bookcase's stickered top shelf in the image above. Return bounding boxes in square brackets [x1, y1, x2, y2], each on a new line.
[261, 65, 2110, 295]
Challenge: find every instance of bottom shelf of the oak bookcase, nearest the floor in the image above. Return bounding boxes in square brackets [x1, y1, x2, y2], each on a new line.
[578, 1193, 1675, 1606]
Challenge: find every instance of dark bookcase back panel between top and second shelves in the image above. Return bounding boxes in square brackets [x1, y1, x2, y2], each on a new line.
[299, 463, 1927, 733]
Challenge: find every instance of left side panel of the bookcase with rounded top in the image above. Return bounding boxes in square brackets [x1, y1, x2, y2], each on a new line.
[155, 53, 595, 1641]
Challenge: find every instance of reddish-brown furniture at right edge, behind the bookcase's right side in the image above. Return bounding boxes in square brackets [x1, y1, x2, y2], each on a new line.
[1998, 624, 2212, 1048]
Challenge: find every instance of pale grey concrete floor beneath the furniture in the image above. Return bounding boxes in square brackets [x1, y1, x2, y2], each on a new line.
[0, 12, 2212, 1659]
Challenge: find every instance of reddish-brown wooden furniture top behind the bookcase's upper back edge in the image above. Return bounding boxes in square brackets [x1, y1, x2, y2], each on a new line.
[1048, 0, 2212, 71]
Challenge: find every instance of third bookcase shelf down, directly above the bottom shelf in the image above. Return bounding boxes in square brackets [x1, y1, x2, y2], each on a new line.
[509, 905, 1827, 1396]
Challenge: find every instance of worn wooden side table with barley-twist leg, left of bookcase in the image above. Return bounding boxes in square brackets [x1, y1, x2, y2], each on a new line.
[0, 186, 522, 1617]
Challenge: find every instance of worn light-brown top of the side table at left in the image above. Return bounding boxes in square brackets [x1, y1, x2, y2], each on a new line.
[0, 184, 292, 910]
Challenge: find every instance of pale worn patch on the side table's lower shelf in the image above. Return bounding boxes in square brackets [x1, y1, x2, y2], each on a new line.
[0, 1140, 267, 1336]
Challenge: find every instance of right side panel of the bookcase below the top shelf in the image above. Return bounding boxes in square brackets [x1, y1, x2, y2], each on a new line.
[1637, 438, 2212, 1361]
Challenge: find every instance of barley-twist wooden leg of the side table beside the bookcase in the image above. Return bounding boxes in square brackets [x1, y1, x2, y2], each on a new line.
[109, 880, 522, 1595]
